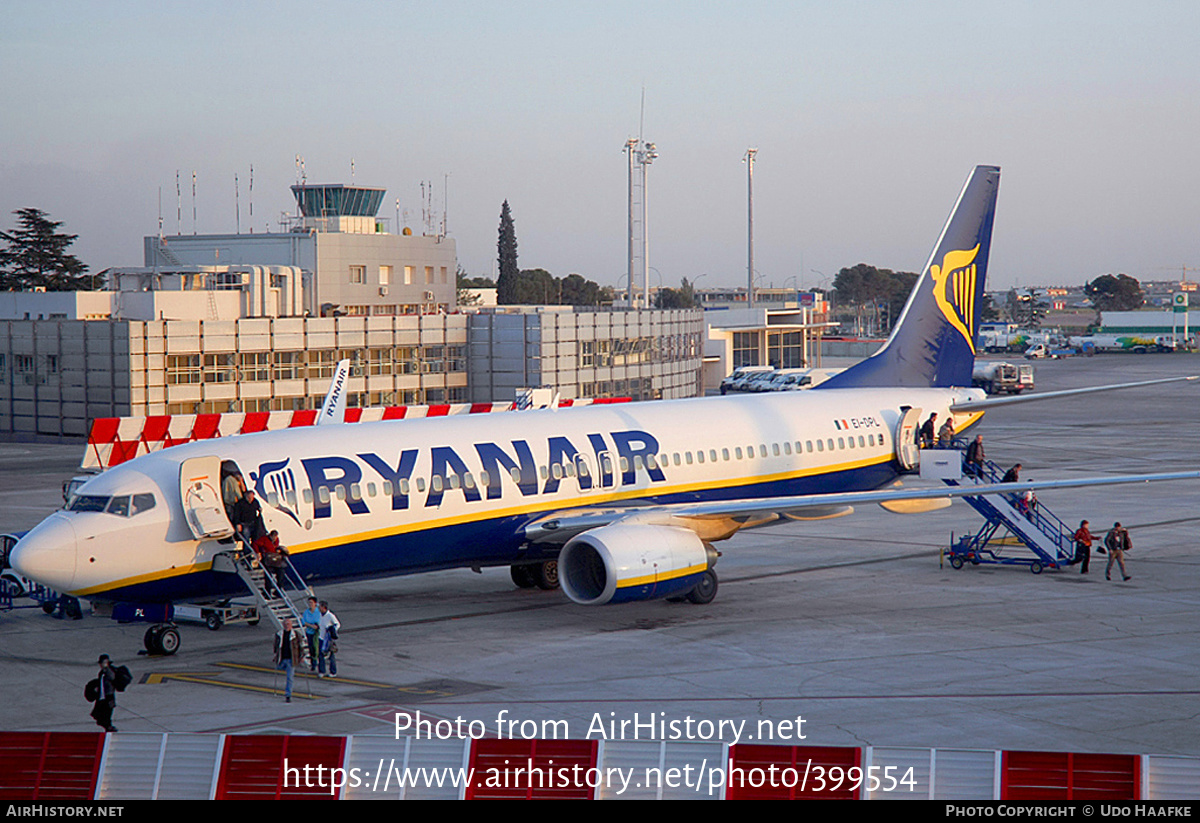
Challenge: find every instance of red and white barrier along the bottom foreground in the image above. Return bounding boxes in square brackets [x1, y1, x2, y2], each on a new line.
[0, 734, 1200, 801]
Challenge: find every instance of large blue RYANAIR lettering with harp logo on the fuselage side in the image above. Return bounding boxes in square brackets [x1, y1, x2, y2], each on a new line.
[250, 429, 666, 523]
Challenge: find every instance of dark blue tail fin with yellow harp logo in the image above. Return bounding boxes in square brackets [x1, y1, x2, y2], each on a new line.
[817, 166, 1000, 389]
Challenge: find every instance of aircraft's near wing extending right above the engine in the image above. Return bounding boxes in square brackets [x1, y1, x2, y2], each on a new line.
[524, 471, 1200, 543]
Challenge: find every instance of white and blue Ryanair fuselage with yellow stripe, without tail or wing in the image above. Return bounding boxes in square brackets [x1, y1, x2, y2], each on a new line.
[13, 389, 983, 601]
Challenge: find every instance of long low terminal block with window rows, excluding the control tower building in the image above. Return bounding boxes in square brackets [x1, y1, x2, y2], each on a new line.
[0, 301, 703, 437]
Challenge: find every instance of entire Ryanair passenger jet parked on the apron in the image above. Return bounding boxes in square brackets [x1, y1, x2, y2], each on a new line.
[12, 166, 1196, 657]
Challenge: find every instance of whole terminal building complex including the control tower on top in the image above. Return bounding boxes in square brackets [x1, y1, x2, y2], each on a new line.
[0, 179, 703, 437]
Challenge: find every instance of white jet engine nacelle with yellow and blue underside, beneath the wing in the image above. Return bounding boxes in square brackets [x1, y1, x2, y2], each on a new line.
[558, 523, 716, 606]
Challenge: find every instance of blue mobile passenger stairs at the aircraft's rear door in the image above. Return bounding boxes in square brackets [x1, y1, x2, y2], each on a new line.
[944, 461, 1075, 575]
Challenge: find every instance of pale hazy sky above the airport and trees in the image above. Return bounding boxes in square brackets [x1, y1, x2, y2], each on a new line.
[0, 0, 1200, 288]
